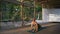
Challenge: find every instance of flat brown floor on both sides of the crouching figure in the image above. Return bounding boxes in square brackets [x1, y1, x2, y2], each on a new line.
[0, 23, 60, 34]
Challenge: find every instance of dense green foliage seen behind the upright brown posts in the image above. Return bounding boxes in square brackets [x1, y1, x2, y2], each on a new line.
[1, 1, 42, 21]
